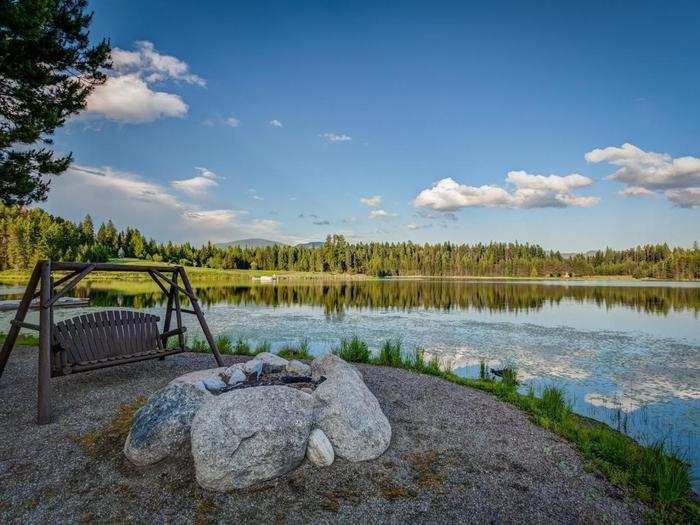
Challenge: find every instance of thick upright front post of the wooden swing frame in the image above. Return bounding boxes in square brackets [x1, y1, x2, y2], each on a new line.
[37, 261, 52, 425]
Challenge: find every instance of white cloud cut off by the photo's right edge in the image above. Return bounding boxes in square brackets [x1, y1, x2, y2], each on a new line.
[585, 143, 700, 208]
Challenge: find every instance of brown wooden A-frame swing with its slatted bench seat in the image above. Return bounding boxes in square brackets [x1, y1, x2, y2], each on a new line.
[0, 261, 223, 424]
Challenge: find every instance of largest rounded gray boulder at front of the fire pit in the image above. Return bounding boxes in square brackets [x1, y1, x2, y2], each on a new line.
[192, 386, 313, 491]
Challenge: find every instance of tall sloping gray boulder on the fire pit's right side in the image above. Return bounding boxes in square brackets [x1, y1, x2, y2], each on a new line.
[311, 355, 391, 461]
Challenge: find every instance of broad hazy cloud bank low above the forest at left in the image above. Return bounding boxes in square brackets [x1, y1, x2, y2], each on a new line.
[46, 165, 296, 242]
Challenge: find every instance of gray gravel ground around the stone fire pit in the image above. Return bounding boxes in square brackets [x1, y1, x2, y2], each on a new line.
[0, 347, 644, 523]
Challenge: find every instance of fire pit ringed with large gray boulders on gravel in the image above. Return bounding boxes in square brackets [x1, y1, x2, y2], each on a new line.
[124, 353, 391, 491]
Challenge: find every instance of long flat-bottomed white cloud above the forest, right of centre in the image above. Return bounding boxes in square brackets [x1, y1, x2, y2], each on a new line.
[413, 171, 600, 212]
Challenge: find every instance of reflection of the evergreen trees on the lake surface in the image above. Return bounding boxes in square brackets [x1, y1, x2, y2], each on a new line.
[76, 281, 700, 319]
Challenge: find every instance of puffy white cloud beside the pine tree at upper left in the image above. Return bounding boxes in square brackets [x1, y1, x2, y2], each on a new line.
[85, 41, 206, 124]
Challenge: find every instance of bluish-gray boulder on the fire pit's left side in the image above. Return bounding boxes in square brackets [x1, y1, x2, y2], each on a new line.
[124, 382, 206, 466]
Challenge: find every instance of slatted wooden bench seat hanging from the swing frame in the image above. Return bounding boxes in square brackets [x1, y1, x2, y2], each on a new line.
[51, 310, 186, 377]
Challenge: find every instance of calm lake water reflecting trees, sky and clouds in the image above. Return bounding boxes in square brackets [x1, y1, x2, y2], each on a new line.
[0, 280, 700, 488]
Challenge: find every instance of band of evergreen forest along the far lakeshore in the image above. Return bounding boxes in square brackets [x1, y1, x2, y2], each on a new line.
[0, 206, 700, 279]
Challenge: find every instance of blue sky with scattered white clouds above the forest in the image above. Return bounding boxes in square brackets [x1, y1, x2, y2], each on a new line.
[41, 0, 700, 251]
